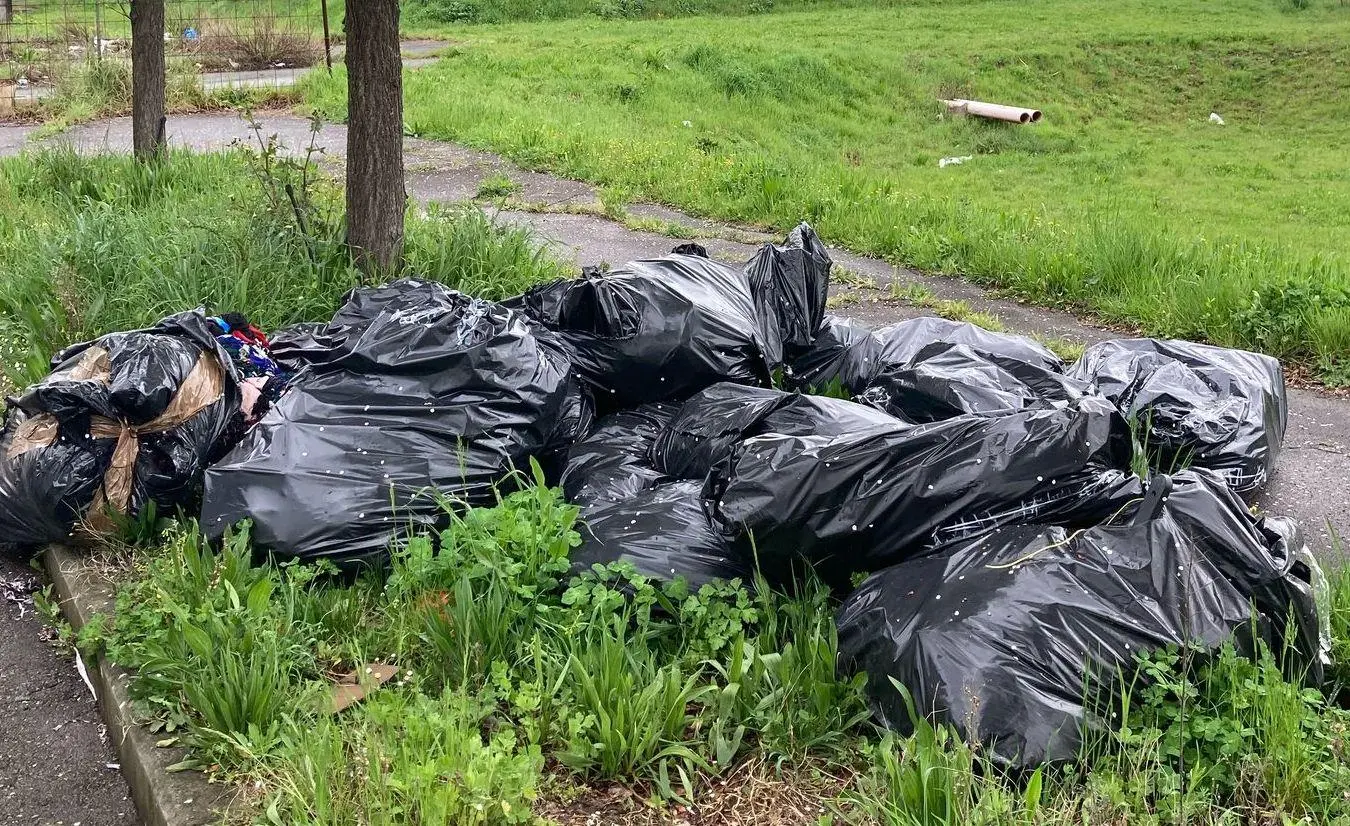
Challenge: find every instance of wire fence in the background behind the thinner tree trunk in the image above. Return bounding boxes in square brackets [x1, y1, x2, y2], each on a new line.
[0, 0, 331, 113]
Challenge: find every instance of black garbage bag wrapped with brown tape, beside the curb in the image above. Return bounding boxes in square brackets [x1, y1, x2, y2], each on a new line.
[0, 310, 244, 545]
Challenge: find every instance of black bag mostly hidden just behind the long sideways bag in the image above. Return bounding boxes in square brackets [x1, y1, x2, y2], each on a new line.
[651, 382, 896, 479]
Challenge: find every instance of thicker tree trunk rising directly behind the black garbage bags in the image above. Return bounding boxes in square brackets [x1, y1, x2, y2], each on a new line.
[344, 0, 408, 273]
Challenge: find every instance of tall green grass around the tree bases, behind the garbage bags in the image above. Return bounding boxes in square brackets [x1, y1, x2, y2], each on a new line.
[0, 139, 562, 386]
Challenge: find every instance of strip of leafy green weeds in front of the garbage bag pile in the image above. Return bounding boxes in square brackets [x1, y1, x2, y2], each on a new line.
[81, 466, 1350, 826]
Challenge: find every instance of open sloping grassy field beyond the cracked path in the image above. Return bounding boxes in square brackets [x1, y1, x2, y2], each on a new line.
[308, 0, 1350, 382]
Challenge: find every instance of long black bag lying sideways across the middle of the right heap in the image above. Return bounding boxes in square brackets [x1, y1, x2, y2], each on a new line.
[705, 397, 1131, 586]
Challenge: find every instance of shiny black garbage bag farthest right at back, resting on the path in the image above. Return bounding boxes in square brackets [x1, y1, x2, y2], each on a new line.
[1069, 339, 1289, 493]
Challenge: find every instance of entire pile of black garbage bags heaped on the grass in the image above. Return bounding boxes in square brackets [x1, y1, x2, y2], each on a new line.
[0, 224, 1326, 767]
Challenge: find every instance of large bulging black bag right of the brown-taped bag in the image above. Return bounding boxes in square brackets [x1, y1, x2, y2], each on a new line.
[203, 279, 572, 564]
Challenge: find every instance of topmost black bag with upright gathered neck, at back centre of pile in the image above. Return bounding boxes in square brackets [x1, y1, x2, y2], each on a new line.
[509, 224, 830, 412]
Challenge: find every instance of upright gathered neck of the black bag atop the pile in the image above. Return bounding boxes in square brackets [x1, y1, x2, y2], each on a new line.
[745, 224, 833, 358]
